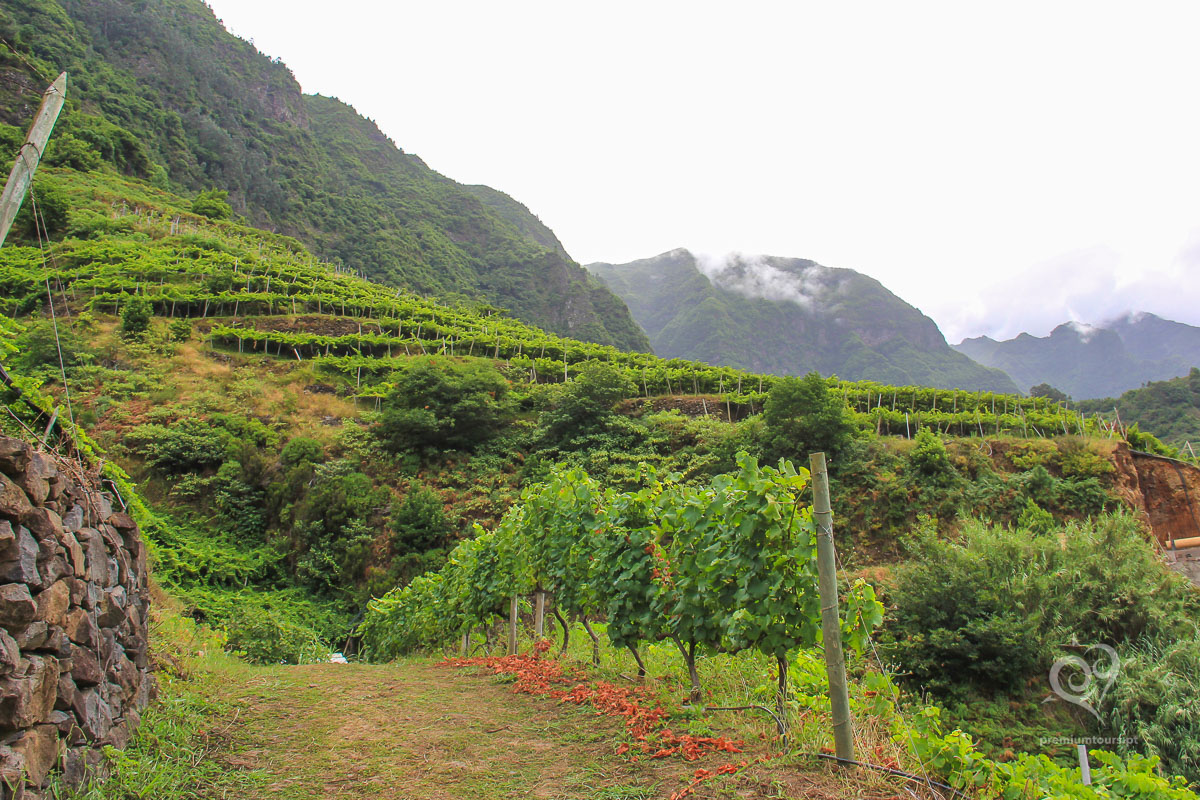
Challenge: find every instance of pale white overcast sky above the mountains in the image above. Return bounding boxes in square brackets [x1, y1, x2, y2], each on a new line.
[210, 0, 1200, 342]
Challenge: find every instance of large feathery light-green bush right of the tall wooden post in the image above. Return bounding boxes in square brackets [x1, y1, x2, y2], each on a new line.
[887, 513, 1200, 696]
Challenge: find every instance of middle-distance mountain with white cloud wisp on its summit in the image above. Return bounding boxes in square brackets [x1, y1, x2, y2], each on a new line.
[588, 249, 1016, 392]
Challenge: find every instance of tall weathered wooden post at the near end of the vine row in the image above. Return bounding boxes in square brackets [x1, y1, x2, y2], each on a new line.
[809, 452, 854, 760]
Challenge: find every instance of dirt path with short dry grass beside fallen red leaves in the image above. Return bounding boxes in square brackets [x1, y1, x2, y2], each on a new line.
[228, 664, 695, 800]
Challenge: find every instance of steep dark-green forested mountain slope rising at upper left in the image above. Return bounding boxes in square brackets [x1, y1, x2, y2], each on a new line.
[0, 0, 649, 350]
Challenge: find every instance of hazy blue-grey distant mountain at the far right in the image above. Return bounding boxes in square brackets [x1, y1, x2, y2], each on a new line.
[954, 313, 1200, 399]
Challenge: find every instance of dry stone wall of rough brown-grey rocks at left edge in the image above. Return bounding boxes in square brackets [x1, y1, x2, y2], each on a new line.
[0, 437, 155, 800]
